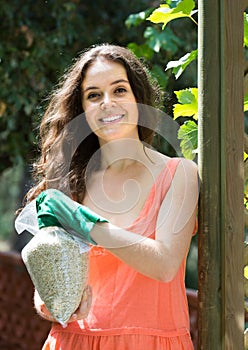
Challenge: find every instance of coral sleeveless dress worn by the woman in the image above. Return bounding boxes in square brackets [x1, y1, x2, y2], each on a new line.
[42, 158, 193, 350]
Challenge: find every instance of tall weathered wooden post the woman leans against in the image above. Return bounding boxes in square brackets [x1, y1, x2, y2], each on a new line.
[198, 0, 244, 350]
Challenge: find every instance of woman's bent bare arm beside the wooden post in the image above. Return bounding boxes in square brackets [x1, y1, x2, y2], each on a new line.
[91, 159, 198, 282]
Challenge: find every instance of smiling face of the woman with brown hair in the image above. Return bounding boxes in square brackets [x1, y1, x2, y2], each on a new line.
[81, 58, 138, 144]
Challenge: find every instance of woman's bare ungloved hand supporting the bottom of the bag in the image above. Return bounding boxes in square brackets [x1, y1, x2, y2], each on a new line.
[34, 285, 92, 323]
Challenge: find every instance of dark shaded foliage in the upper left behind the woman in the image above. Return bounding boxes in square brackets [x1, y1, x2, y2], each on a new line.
[0, 0, 151, 173]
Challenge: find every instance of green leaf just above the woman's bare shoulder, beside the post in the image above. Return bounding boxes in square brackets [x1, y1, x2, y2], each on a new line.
[178, 120, 198, 160]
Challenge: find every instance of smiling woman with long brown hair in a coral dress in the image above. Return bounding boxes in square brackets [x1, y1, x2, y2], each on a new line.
[29, 44, 198, 350]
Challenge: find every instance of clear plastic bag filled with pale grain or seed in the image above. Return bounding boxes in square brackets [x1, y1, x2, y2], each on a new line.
[15, 202, 89, 326]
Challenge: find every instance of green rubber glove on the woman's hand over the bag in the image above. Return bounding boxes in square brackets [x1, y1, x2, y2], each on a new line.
[36, 189, 108, 245]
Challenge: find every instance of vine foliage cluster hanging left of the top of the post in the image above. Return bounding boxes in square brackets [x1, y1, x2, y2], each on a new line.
[125, 0, 197, 93]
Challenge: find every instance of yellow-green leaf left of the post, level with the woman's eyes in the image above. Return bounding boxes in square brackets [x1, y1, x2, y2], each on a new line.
[173, 88, 198, 120]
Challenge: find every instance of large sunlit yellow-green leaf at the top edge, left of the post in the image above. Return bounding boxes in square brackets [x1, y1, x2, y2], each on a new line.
[147, 0, 195, 29]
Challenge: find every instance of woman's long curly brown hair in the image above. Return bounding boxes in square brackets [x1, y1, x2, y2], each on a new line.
[27, 44, 161, 203]
